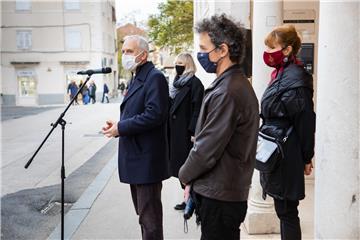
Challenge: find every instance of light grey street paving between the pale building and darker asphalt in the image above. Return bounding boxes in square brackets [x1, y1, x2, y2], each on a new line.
[1, 98, 120, 196]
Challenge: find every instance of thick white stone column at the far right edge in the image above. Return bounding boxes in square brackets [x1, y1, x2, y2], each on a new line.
[315, 1, 360, 239]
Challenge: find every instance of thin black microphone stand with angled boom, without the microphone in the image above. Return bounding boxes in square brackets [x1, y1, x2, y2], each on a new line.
[25, 73, 93, 240]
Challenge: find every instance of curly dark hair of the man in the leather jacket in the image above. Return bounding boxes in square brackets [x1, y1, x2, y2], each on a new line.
[195, 14, 246, 63]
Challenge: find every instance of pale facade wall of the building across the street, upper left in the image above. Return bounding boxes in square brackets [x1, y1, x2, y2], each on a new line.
[1, 1, 117, 105]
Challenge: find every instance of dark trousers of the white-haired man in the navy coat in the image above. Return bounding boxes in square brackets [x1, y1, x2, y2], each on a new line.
[130, 182, 164, 240]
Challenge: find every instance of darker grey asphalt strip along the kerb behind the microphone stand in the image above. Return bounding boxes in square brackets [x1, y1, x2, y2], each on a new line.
[1, 139, 117, 240]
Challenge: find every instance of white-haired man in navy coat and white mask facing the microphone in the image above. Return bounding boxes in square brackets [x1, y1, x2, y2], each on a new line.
[103, 35, 169, 240]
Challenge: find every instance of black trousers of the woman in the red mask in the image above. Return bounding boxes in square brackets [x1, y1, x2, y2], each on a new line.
[274, 199, 301, 240]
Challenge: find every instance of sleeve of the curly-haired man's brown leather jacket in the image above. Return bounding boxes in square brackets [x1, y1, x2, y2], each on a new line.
[179, 93, 241, 184]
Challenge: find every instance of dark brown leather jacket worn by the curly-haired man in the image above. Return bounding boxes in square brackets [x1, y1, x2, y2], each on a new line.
[179, 65, 259, 202]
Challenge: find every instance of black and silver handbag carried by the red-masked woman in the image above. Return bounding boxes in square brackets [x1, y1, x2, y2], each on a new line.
[255, 126, 293, 173]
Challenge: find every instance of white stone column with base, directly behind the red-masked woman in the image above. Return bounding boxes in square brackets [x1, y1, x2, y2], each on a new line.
[245, 0, 283, 234]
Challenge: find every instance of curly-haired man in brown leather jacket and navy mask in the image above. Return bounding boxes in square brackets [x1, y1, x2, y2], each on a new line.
[179, 15, 259, 240]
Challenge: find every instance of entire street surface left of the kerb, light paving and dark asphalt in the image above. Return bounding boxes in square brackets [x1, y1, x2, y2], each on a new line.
[1, 102, 119, 240]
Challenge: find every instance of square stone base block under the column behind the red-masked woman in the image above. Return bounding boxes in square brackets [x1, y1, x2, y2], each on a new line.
[244, 209, 280, 234]
